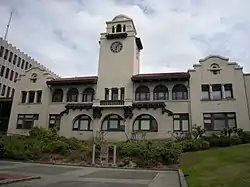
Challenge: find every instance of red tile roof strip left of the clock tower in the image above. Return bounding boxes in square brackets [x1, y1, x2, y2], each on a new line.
[47, 76, 98, 85]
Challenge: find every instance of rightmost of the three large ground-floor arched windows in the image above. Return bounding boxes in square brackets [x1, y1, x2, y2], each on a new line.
[133, 114, 158, 132]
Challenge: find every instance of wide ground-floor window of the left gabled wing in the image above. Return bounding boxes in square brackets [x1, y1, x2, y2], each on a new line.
[16, 114, 39, 130]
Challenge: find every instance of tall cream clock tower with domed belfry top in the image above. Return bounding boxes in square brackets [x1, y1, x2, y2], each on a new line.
[96, 14, 142, 101]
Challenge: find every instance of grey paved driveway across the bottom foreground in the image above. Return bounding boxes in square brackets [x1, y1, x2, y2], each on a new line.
[0, 161, 186, 187]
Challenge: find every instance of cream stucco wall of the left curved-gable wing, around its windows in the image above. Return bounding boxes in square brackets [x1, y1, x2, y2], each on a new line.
[8, 67, 56, 134]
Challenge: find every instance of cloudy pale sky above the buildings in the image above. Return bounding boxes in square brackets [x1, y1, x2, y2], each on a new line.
[0, 0, 250, 77]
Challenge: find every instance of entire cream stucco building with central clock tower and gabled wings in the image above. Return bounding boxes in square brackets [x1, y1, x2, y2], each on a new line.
[8, 15, 250, 141]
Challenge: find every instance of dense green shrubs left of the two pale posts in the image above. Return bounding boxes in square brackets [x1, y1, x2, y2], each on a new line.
[0, 127, 92, 160]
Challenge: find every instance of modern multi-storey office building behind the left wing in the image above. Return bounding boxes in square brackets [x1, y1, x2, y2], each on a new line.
[0, 38, 57, 131]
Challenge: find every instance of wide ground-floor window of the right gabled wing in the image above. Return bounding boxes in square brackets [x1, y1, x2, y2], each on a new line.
[203, 112, 237, 131]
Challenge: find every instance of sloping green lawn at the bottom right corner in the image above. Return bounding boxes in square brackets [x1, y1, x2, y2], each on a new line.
[181, 144, 250, 187]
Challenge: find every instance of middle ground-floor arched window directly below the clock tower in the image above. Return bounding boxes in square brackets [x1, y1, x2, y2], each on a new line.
[102, 114, 125, 131]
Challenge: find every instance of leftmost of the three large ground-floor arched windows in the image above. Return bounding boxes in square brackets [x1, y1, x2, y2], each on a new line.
[73, 114, 93, 131]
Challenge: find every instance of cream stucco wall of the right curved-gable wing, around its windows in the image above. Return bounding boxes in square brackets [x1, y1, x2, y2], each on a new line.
[189, 57, 250, 130]
